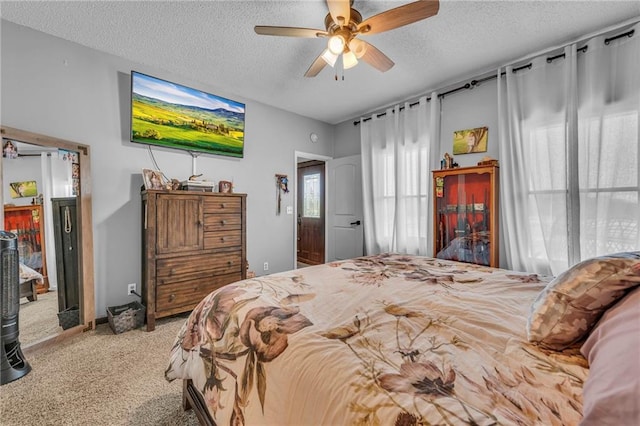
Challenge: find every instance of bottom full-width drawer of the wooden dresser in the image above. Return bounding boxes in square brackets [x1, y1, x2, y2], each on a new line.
[156, 273, 242, 315]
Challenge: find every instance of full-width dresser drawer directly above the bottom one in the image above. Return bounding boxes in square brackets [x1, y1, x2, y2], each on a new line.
[156, 251, 242, 283]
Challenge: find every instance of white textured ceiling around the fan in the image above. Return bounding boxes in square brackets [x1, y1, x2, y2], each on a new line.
[0, 0, 640, 124]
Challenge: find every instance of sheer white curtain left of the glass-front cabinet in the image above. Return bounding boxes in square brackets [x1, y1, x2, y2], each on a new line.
[361, 93, 440, 255]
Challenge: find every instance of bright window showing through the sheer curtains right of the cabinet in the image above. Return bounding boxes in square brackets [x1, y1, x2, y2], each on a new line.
[525, 105, 640, 271]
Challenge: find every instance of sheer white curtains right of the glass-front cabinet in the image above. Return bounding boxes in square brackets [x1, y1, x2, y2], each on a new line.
[498, 24, 640, 275]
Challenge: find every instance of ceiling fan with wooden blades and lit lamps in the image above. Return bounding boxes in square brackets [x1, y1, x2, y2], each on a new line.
[255, 0, 440, 77]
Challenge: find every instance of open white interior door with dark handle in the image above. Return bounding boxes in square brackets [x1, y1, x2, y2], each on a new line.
[327, 155, 364, 262]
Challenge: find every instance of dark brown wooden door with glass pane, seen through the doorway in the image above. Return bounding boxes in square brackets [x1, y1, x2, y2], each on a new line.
[297, 161, 325, 265]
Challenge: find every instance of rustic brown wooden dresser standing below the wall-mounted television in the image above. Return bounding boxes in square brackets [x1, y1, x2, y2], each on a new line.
[142, 190, 246, 331]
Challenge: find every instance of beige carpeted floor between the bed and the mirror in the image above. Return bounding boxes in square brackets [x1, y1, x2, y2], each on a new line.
[0, 315, 198, 426]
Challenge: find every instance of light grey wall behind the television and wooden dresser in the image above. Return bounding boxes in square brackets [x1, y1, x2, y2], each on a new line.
[0, 21, 334, 317]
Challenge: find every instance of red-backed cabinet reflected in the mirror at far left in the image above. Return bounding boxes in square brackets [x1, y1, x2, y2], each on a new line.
[4, 204, 49, 294]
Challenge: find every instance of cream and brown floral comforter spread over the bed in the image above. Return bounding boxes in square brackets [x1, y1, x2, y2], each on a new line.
[166, 255, 587, 426]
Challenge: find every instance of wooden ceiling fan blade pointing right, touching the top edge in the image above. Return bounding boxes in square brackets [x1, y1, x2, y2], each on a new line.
[358, 0, 440, 34]
